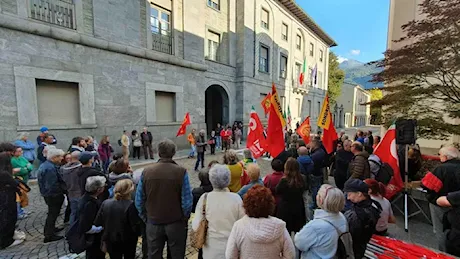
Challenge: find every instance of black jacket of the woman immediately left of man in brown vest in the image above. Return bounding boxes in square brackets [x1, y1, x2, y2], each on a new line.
[95, 199, 142, 243]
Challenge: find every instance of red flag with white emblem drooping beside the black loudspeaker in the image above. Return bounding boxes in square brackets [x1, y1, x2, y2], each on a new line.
[374, 125, 404, 199]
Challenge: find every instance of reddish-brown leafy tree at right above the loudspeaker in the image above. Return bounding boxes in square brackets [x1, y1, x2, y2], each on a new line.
[372, 0, 460, 139]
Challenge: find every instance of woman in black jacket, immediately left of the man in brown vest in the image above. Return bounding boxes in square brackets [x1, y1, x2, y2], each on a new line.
[94, 179, 142, 260]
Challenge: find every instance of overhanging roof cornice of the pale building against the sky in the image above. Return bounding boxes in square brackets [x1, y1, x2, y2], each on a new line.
[278, 0, 337, 47]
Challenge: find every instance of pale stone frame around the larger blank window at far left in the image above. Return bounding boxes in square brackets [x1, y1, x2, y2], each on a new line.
[14, 66, 97, 131]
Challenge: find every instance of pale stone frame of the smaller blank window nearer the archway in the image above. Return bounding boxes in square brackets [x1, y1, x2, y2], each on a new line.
[145, 82, 184, 126]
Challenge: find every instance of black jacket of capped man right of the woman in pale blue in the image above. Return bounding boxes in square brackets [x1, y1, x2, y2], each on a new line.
[345, 198, 382, 259]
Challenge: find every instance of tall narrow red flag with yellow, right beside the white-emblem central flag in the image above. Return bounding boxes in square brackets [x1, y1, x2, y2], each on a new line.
[267, 83, 286, 157]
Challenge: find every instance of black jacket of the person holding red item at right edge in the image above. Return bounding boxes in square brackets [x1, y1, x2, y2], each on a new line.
[426, 159, 460, 205]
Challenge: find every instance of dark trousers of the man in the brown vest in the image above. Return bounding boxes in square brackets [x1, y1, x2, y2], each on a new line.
[147, 220, 187, 260]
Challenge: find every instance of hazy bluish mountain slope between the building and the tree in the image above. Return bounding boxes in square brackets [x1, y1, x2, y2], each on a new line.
[339, 60, 383, 89]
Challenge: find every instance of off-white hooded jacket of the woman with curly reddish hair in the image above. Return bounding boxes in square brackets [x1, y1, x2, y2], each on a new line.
[225, 216, 295, 260]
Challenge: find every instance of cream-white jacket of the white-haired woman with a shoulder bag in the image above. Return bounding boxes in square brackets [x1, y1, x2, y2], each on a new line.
[192, 188, 245, 259]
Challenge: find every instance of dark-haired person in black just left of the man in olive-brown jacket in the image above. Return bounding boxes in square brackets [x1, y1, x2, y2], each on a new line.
[334, 140, 354, 190]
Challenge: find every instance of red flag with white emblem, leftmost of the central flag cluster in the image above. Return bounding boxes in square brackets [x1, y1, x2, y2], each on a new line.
[246, 107, 266, 159]
